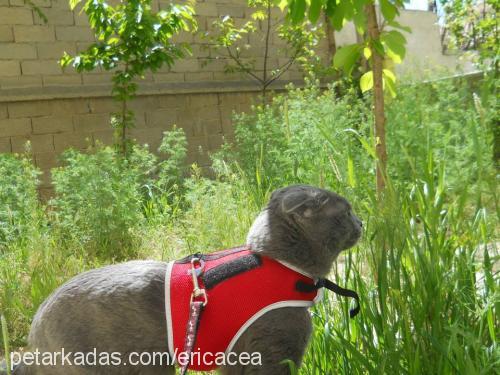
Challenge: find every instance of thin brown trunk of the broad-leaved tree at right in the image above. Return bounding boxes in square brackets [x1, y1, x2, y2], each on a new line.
[365, 2, 387, 199]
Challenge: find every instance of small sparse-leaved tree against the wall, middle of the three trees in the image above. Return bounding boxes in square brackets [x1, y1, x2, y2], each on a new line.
[206, 0, 323, 100]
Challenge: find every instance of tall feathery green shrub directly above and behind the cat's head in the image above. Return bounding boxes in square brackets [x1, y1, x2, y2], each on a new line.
[216, 82, 374, 203]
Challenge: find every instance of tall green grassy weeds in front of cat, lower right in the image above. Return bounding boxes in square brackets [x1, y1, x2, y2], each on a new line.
[303, 158, 500, 374]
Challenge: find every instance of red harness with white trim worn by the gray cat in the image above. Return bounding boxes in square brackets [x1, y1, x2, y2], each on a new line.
[165, 247, 322, 371]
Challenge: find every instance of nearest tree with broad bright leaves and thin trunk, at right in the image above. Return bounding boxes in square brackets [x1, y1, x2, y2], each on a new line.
[280, 0, 410, 198]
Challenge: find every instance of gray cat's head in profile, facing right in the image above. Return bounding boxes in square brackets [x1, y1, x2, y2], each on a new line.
[247, 185, 362, 277]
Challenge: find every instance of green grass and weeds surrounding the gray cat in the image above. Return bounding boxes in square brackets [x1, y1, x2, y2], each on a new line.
[0, 76, 500, 375]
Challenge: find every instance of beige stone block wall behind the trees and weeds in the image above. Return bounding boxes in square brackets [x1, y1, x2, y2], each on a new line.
[0, 0, 468, 197]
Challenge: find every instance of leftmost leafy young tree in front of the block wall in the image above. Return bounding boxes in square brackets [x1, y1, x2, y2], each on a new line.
[61, 0, 196, 157]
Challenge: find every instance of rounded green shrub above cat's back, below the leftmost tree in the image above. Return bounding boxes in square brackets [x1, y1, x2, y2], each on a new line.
[50, 146, 155, 259]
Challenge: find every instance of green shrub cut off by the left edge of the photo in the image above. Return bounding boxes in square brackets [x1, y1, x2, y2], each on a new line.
[0, 154, 41, 250]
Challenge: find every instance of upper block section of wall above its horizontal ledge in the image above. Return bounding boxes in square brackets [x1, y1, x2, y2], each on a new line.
[0, 0, 316, 90]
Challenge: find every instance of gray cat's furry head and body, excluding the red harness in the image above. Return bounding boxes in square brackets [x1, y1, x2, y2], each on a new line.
[9, 185, 362, 375]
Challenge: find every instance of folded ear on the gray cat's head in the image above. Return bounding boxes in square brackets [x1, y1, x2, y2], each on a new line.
[281, 187, 328, 218]
